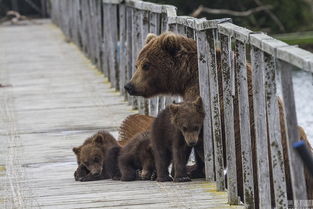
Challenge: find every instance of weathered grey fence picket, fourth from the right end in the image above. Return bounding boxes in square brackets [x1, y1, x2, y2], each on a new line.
[235, 40, 255, 208]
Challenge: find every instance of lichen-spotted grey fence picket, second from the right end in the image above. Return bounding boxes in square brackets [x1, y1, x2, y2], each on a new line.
[264, 53, 288, 208]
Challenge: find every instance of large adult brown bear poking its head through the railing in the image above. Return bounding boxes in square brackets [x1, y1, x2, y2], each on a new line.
[125, 32, 309, 202]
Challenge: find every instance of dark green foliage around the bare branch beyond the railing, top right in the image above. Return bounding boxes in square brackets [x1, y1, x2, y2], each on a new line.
[144, 0, 313, 33]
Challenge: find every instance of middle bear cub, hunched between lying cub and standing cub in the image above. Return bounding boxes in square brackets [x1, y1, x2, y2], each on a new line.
[118, 131, 155, 181]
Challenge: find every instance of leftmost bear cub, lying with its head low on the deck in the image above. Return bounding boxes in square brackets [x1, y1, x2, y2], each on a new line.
[73, 131, 119, 181]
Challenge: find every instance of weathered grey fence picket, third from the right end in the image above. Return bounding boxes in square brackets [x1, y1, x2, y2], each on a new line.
[251, 46, 271, 209]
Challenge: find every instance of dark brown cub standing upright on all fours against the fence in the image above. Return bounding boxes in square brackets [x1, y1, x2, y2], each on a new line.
[151, 97, 205, 182]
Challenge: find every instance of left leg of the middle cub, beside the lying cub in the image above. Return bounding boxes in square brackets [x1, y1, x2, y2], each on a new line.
[119, 155, 136, 181]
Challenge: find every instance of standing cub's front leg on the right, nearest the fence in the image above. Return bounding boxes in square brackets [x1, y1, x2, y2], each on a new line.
[173, 145, 191, 182]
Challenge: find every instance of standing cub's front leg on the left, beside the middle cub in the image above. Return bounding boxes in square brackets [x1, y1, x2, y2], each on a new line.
[153, 149, 172, 182]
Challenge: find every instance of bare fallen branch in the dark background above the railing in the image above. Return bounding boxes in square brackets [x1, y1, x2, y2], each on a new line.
[191, 5, 273, 17]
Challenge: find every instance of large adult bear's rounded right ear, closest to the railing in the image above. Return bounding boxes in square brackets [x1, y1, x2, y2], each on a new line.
[161, 32, 180, 56]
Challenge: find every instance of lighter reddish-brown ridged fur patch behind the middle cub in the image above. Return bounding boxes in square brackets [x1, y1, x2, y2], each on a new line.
[118, 114, 155, 146]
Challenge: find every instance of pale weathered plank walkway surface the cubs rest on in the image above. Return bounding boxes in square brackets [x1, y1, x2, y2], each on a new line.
[0, 21, 242, 209]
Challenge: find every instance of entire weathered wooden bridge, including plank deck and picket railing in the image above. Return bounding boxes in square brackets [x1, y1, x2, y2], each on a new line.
[0, 0, 313, 209]
